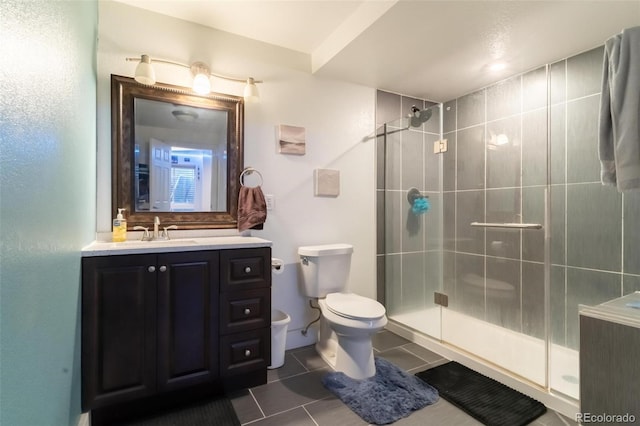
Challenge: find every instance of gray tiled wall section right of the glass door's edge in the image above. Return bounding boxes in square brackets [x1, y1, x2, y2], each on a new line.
[550, 47, 640, 349]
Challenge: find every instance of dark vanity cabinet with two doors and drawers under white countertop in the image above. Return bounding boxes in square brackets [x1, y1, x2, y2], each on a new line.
[82, 247, 271, 411]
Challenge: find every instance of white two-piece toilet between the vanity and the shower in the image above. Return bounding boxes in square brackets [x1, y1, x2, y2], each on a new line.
[298, 244, 387, 380]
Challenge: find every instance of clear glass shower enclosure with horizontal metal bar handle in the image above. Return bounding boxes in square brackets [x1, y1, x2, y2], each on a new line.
[378, 91, 578, 410]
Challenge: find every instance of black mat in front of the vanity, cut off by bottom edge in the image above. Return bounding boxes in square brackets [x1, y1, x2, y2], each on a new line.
[119, 396, 240, 426]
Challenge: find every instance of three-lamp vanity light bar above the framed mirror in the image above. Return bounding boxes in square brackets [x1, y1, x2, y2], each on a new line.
[126, 55, 262, 102]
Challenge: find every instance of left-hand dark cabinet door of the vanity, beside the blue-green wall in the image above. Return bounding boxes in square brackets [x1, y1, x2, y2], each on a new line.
[82, 255, 156, 411]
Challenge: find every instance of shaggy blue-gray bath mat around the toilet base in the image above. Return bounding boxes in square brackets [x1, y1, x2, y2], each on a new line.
[322, 358, 438, 425]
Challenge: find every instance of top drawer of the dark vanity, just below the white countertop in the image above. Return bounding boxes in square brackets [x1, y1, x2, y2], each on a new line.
[220, 247, 271, 292]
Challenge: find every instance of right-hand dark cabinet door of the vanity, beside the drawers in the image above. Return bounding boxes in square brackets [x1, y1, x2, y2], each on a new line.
[158, 251, 219, 391]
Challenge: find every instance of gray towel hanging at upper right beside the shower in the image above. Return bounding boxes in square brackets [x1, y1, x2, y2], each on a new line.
[598, 27, 640, 192]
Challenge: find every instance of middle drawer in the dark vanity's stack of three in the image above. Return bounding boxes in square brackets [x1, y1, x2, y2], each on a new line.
[220, 288, 271, 334]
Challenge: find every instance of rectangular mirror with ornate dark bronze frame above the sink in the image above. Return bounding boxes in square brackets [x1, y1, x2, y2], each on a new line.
[111, 75, 244, 230]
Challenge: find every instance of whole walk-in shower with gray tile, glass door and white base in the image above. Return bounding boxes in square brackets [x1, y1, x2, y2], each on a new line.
[376, 44, 640, 412]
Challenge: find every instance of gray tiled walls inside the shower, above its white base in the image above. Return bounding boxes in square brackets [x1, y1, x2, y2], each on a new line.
[377, 47, 640, 349]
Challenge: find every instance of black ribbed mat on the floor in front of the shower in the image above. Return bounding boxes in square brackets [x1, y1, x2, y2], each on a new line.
[416, 361, 547, 426]
